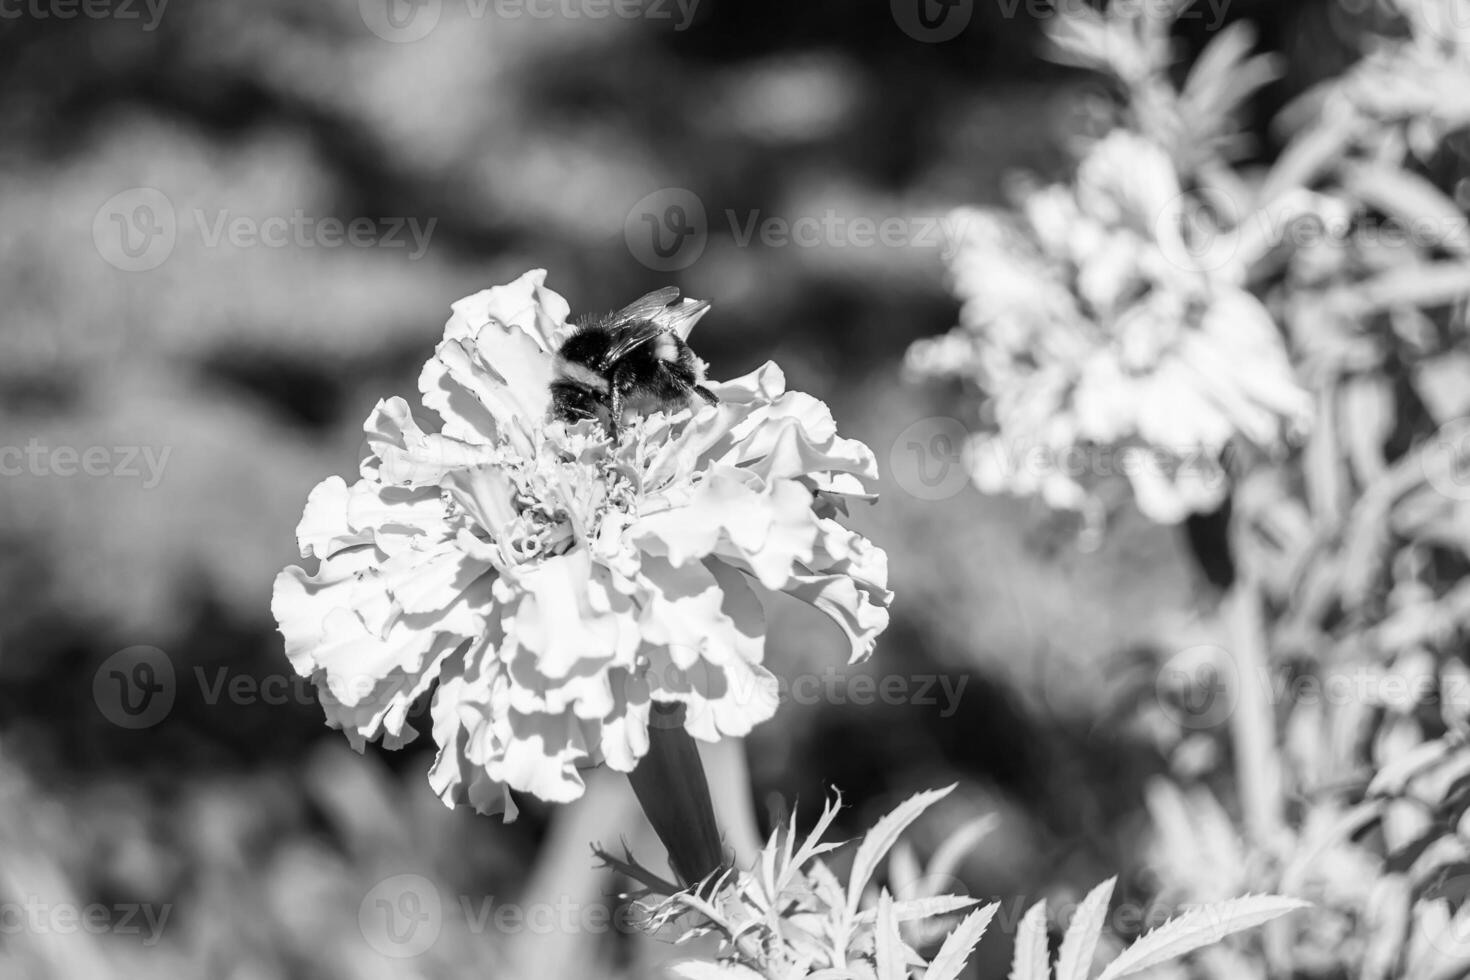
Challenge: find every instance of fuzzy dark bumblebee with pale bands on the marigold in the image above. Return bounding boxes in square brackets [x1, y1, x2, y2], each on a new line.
[551, 287, 719, 438]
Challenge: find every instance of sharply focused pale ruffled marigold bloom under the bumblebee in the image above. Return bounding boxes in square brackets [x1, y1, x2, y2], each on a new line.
[272, 270, 891, 820]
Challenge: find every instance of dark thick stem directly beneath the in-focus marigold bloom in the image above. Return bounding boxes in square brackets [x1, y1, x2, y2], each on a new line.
[628, 702, 725, 886]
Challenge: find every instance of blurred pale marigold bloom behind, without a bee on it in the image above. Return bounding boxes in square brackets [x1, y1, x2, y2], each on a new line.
[908, 131, 1311, 523]
